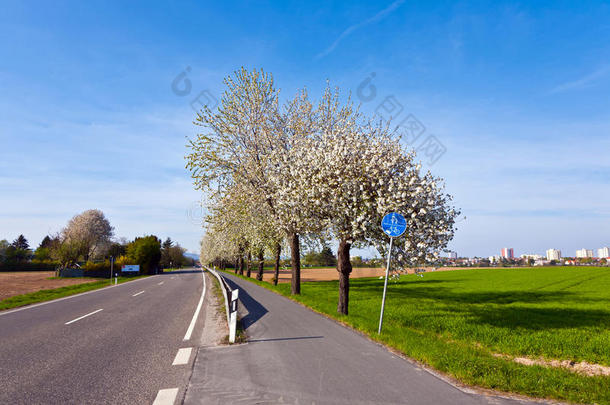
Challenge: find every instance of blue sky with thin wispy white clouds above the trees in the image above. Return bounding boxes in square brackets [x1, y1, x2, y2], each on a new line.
[0, 1, 610, 256]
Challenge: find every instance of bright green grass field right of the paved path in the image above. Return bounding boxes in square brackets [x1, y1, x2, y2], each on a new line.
[224, 267, 610, 404]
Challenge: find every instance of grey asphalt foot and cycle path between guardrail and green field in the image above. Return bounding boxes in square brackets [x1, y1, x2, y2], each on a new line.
[184, 276, 536, 405]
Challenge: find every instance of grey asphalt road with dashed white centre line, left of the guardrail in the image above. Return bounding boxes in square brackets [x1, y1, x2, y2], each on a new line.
[0, 270, 207, 404]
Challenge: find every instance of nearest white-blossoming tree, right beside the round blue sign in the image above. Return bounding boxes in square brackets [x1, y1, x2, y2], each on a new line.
[290, 89, 458, 314]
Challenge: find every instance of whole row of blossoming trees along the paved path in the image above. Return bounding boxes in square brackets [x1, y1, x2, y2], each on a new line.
[186, 68, 459, 314]
